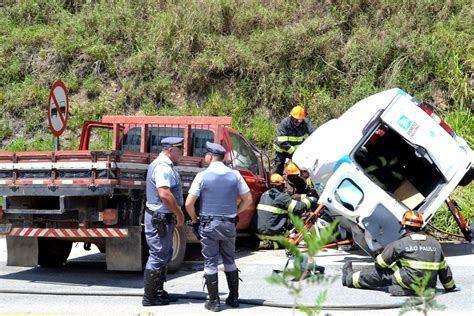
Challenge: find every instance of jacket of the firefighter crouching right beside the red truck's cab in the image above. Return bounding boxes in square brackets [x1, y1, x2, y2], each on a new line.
[252, 188, 317, 239]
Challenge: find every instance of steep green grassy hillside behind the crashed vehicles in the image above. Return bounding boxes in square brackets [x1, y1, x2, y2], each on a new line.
[0, 0, 474, 232]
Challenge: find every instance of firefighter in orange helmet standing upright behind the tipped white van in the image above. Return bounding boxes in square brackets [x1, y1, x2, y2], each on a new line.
[273, 105, 314, 175]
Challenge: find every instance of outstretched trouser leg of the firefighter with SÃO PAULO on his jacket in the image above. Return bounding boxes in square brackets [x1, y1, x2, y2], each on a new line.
[346, 266, 393, 289]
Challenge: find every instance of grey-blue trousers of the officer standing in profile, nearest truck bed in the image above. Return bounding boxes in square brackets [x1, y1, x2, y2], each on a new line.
[145, 212, 175, 271]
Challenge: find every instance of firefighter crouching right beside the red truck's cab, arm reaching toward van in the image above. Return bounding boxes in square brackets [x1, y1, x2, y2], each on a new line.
[252, 173, 317, 249]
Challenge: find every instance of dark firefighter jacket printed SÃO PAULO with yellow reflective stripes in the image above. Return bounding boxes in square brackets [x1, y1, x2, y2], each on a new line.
[375, 233, 456, 291]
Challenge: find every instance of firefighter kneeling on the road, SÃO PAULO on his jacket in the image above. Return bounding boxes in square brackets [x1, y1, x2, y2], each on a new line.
[342, 210, 456, 296]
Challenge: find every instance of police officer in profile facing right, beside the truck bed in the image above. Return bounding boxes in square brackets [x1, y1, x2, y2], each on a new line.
[142, 137, 184, 306]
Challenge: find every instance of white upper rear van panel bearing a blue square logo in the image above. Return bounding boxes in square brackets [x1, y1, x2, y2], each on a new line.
[381, 95, 468, 181]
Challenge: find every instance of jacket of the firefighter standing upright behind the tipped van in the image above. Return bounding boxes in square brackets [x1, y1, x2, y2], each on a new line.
[273, 116, 314, 155]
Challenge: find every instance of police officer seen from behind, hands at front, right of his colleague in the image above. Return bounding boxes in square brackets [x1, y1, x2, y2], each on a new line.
[186, 142, 252, 312]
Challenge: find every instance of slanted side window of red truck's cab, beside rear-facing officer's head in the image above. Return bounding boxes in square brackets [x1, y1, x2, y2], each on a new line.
[229, 133, 260, 175]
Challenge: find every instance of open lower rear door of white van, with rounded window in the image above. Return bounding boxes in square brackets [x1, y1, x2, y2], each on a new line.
[316, 163, 405, 251]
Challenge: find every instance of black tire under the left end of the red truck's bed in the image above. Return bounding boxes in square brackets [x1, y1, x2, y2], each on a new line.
[38, 238, 72, 268]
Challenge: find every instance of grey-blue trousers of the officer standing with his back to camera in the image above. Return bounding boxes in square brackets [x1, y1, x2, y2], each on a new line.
[199, 220, 237, 274]
